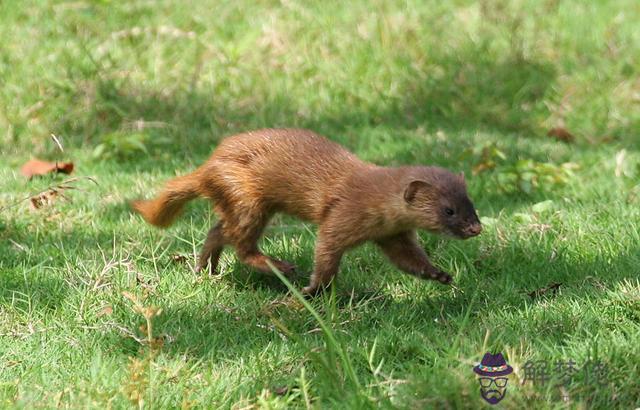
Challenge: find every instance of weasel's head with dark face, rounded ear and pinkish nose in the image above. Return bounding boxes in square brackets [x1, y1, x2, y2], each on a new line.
[404, 167, 482, 239]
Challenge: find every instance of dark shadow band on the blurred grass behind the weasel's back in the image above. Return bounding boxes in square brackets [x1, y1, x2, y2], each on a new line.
[51, 54, 556, 168]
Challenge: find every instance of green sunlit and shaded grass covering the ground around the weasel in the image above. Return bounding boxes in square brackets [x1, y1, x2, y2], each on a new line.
[0, 0, 640, 408]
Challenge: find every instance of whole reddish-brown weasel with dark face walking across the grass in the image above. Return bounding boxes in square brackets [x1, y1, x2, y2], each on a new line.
[132, 129, 482, 294]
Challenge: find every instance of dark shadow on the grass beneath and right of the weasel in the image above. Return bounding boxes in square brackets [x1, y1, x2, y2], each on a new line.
[97, 240, 640, 366]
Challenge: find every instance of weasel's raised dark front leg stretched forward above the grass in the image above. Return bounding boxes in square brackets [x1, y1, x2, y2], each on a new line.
[376, 231, 452, 284]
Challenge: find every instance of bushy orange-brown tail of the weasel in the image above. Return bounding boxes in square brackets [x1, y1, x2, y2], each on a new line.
[131, 174, 199, 228]
